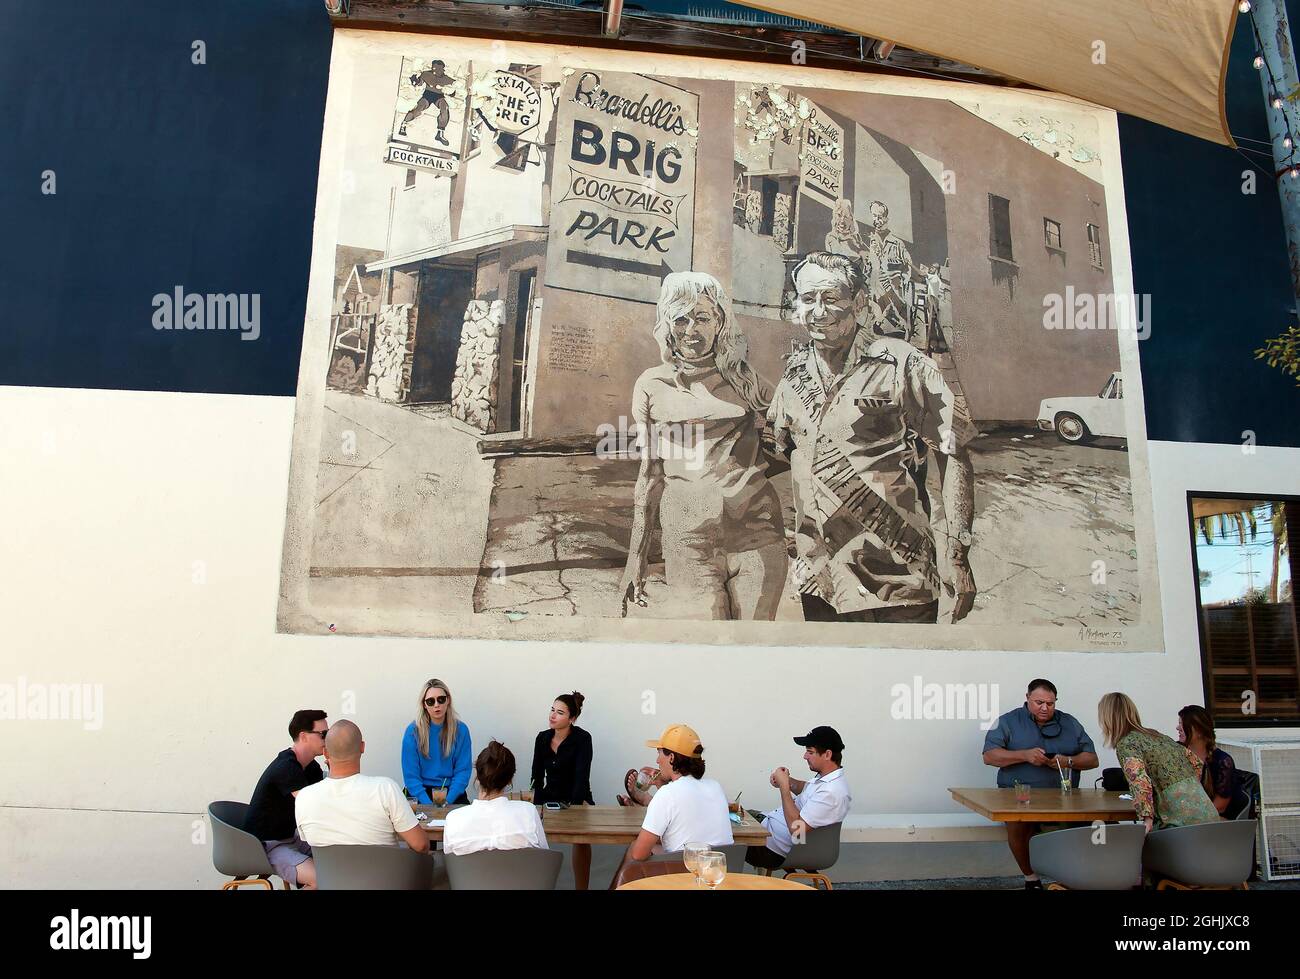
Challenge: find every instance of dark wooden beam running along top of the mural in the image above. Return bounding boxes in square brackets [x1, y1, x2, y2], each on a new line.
[325, 0, 998, 87]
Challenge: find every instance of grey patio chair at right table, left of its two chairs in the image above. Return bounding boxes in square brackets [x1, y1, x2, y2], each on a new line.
[1030, 823, 1147, 891]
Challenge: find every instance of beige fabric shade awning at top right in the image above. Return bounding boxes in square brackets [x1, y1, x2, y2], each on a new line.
[742, 0, 1236, 146]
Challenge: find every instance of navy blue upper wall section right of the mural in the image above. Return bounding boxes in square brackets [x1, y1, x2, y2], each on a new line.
[1119, 3, 1300, 446]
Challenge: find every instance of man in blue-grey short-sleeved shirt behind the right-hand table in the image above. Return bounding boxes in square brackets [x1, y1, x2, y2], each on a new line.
[984, 679, 1097, 891]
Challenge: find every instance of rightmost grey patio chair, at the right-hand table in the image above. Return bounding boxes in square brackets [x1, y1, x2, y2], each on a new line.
[1141, 819, 1258, 891]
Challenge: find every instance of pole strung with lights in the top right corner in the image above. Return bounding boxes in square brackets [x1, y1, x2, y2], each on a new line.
[1249, 0, 1300, 313]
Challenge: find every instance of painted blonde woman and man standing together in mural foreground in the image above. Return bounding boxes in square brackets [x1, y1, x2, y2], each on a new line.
[620, 248, 976, 623]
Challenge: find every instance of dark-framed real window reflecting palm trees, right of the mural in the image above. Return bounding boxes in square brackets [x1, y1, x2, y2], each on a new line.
[1188, 495, 1300, 725]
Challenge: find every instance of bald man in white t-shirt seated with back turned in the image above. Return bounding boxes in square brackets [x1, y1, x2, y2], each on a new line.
[295, 720, 429, 853]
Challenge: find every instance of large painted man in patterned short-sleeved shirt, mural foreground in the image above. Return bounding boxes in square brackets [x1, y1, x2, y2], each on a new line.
[767, 252, 976, 623]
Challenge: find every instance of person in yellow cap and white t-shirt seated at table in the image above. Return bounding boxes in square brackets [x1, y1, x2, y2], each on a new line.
[614, 724, 735, 880]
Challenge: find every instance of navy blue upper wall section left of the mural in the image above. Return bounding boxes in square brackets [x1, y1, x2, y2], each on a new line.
[0, 0, 332, 395]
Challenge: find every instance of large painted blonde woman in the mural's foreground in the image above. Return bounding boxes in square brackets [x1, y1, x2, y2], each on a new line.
[620, 272, 787, 619]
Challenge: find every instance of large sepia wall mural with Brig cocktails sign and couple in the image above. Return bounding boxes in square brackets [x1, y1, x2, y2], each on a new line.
[280, 31, 1161, 650]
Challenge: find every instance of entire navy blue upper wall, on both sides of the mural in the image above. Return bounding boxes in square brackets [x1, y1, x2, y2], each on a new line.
[0, 0, 1300, 446]
